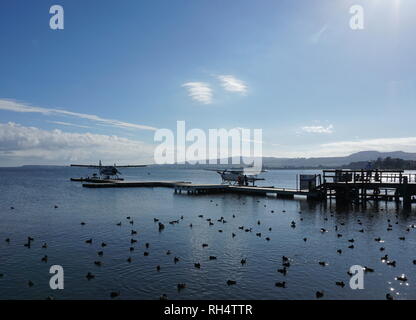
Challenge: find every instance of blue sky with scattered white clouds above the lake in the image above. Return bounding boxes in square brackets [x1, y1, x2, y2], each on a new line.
[0, 0, 416, 166]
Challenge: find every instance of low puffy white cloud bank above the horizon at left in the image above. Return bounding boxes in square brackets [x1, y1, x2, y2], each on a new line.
[0, 122, 154, 165]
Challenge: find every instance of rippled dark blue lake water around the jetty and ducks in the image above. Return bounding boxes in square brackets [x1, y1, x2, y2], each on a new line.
[0, 167, 416, 299]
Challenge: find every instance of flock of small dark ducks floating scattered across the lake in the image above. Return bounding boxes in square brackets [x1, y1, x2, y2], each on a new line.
[0, 200, 416, 300]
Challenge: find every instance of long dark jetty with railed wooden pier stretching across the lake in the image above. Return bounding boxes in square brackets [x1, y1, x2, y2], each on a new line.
[71, 170, 416, 208]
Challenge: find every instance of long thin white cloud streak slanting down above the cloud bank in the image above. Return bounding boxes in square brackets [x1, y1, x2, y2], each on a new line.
[0, 99, 157, 131]
